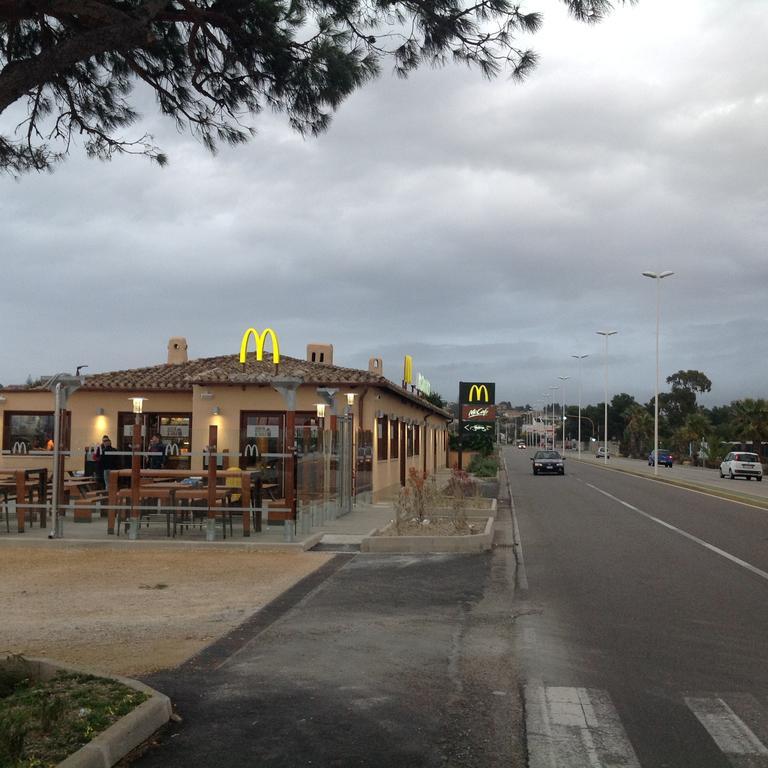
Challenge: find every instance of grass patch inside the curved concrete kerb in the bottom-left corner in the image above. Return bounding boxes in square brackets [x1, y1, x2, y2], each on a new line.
[0, 656, 149, 768]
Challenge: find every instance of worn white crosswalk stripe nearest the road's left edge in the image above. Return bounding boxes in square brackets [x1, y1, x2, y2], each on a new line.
[525, 685, 640, 768]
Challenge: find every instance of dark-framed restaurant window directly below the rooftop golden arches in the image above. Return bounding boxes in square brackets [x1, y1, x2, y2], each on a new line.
[240, 411, 285, 498]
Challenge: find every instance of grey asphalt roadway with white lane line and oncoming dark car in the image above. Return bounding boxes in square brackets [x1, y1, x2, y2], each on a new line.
[505, 448, 768, 768]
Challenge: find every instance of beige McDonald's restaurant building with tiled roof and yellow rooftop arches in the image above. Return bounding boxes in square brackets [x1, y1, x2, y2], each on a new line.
[0, 332, 451, 502]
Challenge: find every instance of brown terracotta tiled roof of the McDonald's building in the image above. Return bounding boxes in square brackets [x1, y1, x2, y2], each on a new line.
[72, 352, 449, 416]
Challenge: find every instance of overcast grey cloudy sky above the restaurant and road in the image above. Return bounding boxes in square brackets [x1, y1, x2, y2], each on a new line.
[0, 0, 768, 412]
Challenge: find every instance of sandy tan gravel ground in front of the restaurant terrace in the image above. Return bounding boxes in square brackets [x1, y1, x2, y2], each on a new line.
[0, 545, 331, 677]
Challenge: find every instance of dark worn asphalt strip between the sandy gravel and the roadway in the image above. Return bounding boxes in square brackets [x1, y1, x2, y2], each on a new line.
[135, 513, 524, 768]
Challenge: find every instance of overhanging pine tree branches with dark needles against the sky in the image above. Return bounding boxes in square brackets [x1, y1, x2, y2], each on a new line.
[0, 0, 636, 173]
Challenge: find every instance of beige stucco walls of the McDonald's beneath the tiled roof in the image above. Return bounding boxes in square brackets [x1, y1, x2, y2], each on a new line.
[0, 385, 446, 499]
